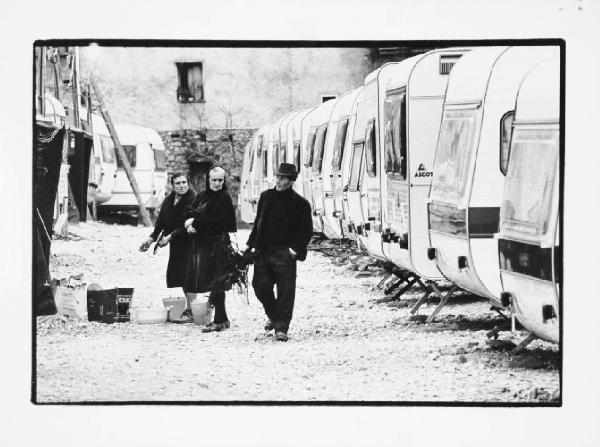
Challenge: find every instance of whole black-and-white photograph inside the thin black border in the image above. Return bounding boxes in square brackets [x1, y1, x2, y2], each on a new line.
[32, 41, 562, 405]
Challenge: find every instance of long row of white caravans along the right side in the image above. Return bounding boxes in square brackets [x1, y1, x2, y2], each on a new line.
[239, 46, 562, 342]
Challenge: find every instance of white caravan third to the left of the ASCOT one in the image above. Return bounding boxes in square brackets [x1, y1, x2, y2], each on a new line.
[324, 87, 362, 239]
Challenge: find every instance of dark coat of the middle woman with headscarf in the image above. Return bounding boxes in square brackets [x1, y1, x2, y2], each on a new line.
[184, 188, 237, 293]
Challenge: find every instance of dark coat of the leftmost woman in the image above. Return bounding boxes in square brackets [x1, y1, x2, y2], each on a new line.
[150, 189, 196, 287]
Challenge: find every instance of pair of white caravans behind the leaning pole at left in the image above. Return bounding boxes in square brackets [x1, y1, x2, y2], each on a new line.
[89, 114, 167, 211]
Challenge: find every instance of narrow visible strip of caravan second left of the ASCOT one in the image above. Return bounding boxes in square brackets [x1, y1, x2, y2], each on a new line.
[342, 87, 365, 249]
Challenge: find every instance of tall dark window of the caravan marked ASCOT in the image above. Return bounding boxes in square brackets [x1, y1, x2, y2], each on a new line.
[383, 91, 406, 180]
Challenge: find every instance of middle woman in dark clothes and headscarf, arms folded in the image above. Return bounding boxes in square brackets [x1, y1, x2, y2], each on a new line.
[184, 166, 237, 332]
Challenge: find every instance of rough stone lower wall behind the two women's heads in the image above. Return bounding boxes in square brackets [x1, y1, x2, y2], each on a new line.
[159, 129, 256, 227]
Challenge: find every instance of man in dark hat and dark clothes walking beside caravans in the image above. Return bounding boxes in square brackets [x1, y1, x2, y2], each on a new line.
[247, 163, 312, 341]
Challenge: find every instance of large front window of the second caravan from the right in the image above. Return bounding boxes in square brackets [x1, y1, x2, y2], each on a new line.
[431, 109, 477, 203]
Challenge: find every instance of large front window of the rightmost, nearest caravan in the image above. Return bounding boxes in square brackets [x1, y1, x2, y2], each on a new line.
[500, 128, 558, 240]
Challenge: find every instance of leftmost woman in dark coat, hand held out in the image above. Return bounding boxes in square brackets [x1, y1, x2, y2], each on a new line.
[140, 171, 196, 306]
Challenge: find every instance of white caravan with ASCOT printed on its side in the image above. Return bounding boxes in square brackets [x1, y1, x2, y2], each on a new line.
[378, 49, 465, 280]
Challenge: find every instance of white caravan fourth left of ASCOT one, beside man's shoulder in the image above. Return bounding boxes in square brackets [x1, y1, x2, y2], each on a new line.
[302, 99, 337, 233]
